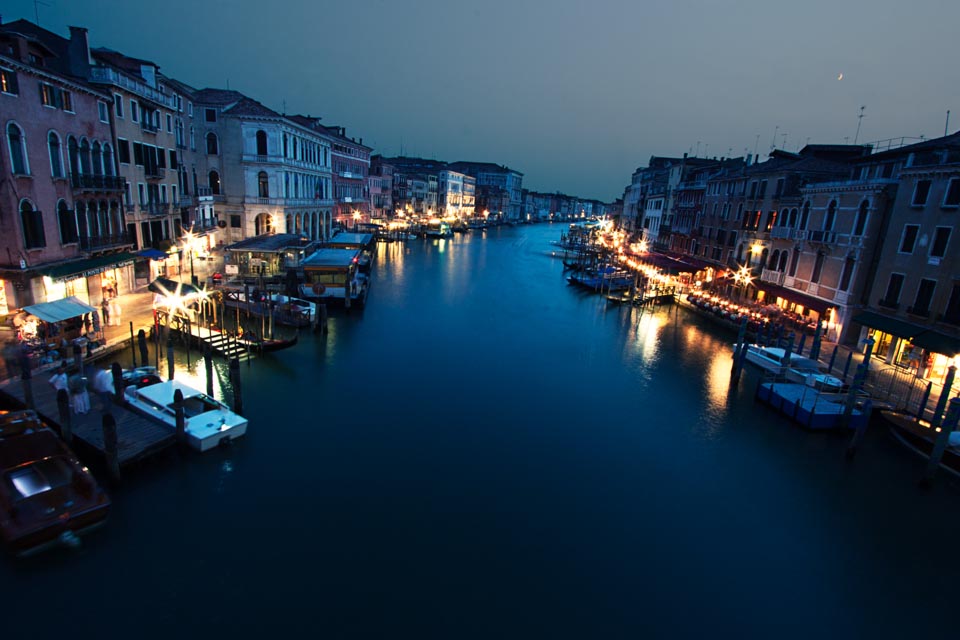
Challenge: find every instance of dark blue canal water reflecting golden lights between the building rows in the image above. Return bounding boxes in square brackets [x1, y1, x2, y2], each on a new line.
[0, 225, 960, 638]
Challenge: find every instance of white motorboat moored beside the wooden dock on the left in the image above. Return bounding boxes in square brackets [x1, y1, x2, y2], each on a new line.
[124, 380, 247, 451]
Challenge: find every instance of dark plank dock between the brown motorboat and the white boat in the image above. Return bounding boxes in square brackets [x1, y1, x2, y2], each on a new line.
[0, 376, 176, 467]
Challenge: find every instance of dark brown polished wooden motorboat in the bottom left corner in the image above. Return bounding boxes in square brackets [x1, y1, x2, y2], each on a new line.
[0, 411, 110, 556]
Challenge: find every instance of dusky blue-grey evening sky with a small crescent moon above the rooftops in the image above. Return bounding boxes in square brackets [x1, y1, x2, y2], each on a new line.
[9, 0, 960, 200]
